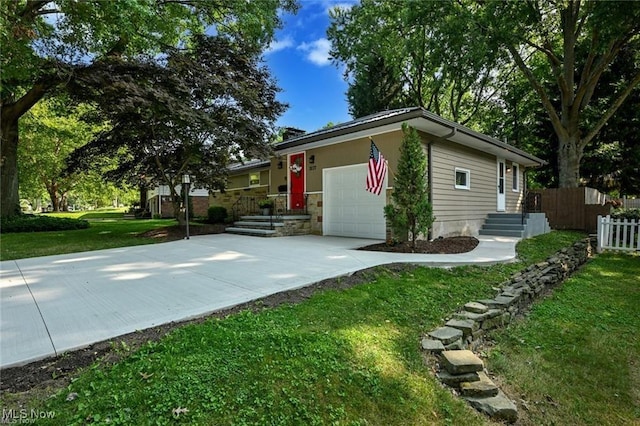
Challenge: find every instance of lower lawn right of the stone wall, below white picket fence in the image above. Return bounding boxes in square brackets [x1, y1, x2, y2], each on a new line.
[489, 253, 640, 425]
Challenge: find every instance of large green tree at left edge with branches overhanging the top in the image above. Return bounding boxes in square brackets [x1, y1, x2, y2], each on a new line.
[0, 0, 296, 216]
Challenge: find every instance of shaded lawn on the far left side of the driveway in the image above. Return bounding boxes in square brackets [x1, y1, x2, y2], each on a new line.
[0, 218, 177, 260]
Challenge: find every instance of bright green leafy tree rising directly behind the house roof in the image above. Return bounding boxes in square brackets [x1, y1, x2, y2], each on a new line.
[327, 0, 504, 124]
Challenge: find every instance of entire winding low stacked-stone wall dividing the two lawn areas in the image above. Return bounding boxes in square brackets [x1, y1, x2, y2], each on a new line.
[421, 239, 592, 422]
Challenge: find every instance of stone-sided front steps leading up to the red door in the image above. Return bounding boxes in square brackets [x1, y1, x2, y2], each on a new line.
[226, 215, 311, 237]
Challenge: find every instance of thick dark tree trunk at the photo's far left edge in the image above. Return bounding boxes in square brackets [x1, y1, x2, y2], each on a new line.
[0, 112, 20, 217]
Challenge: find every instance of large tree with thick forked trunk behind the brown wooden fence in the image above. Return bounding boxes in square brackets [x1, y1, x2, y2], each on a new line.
[467, 0, 640, 187]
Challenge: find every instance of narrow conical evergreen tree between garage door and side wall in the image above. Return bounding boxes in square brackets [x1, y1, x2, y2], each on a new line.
[384, 123, 435, 249]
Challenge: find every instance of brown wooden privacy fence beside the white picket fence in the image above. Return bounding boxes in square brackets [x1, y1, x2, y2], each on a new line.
[530, 188, 611, 232]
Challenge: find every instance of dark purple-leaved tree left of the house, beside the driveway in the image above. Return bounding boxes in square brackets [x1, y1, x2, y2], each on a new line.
[69, 35, 285, 221]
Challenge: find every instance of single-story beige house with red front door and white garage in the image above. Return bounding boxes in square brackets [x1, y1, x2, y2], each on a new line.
[210, 108, 544, 239]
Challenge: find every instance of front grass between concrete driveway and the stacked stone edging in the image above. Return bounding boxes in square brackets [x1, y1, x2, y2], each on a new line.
[0, 232, 592, 425]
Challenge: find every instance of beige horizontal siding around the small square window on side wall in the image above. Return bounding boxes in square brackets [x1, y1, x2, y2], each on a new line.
[431, 142, 497, 237]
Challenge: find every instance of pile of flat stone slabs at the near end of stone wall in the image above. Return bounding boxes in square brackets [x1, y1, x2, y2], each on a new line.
[438, 350, 518, 422]
